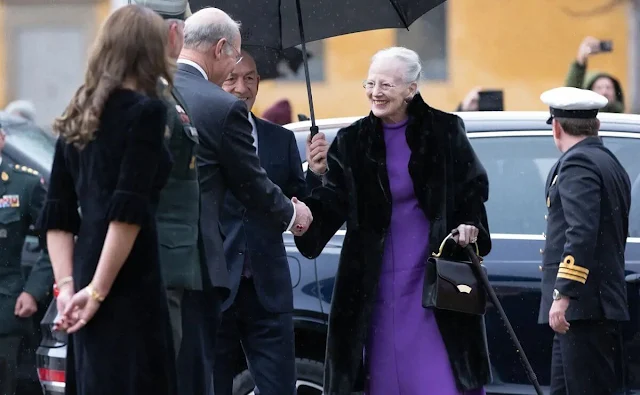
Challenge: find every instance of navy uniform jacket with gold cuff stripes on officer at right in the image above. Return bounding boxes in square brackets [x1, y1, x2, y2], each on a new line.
[538, 137, 631, 323]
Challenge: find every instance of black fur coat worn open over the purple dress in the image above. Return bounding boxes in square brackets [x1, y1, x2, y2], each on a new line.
[295, 94, 491, 395]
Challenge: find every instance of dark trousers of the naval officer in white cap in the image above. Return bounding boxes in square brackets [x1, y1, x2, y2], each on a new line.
[550, 321, 624, 395]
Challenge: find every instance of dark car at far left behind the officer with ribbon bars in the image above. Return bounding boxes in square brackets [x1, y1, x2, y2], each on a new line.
[0, 112, 55, 395]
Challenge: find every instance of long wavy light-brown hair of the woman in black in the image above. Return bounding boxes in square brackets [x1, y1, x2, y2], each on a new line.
[53, 5, 175, 149]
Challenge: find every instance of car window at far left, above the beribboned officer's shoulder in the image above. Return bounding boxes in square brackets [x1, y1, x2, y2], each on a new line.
[3, 123, 55, 170]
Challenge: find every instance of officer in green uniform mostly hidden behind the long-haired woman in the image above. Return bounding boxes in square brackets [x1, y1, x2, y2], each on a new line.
[133, 0, 202, 356]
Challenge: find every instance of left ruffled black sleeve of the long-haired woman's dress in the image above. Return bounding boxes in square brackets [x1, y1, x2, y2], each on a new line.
[35, 138, 80, 234]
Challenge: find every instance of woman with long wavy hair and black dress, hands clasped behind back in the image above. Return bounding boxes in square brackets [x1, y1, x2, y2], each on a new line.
[38, 5, 176, 395]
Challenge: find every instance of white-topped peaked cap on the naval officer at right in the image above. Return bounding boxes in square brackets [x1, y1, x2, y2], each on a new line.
[540, 87, 609, 124]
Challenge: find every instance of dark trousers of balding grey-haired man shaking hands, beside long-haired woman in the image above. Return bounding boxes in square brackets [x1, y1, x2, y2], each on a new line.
[177, 290, 220, 395]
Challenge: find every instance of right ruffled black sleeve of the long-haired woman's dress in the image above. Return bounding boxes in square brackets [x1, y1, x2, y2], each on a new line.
[107, 99, 166, 225]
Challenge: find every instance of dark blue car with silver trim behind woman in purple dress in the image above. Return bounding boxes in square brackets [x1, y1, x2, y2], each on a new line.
[38, 112, 640, 395]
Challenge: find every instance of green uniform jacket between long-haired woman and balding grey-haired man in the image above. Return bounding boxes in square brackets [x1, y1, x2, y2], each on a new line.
[156, 81, 202, 290]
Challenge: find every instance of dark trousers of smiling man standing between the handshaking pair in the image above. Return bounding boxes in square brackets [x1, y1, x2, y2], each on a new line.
[214, 277, 296, 395]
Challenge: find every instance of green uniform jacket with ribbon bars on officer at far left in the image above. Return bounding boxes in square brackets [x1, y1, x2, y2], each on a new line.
[0, 160, 53, 335]
